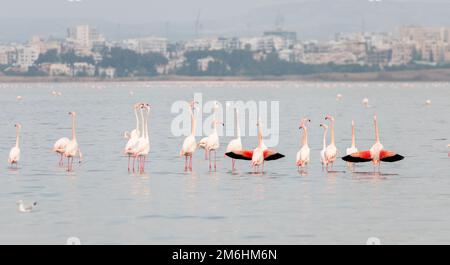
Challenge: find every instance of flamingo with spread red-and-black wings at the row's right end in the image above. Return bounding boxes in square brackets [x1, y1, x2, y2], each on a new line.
[342, 115, 404, 171]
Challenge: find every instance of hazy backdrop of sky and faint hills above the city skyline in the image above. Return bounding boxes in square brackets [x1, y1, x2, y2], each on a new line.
[0, 0, 450, 41]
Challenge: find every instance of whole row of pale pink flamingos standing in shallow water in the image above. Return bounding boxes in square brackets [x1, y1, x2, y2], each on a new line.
[8, 95, 450, 173]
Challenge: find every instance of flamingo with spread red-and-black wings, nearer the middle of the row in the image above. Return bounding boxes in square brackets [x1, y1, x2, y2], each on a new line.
[225, 118, 284, 171]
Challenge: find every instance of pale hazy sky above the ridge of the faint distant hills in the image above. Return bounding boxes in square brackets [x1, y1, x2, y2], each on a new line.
[0, 0, 302, 23]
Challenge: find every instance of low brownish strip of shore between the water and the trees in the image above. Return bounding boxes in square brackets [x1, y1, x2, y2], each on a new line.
[0, 69, 450, 83]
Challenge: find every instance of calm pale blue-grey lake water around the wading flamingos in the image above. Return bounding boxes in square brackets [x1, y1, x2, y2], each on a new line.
[0, 82, 450, 244]
